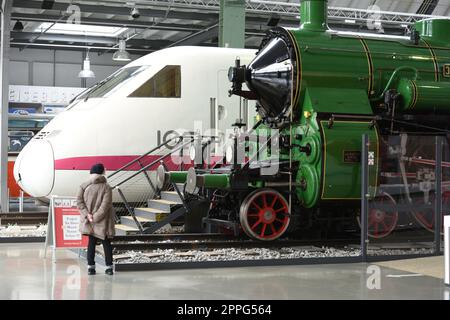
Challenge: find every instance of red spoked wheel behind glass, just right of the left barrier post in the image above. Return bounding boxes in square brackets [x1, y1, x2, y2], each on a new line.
[368, 192, 398, 239]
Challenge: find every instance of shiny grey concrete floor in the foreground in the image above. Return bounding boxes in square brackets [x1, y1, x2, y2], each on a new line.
[0, 244, 450, 300]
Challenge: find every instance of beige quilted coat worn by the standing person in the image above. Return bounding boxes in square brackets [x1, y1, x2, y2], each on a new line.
[77, 174, 115, 240]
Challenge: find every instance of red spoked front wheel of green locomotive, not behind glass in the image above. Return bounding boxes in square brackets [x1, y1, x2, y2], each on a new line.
[239, 189, 291, 241]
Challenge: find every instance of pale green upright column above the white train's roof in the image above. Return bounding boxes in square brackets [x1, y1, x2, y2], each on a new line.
[219, 0, 245, 48]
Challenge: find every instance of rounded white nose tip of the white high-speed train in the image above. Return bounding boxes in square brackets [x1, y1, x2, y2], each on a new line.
[14, 140, 55, 198]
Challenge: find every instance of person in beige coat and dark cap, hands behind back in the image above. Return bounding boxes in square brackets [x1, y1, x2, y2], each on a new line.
[77, 163, 115, 275]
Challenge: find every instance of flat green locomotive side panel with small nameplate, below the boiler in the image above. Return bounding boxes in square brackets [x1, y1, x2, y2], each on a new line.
[320, 121, 379, 200]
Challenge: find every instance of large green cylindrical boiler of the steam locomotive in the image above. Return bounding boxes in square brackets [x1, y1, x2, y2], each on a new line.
[288, 25, 450, 115]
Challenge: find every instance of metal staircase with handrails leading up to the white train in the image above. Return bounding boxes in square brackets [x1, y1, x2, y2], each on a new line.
[108, 136, 214, 235]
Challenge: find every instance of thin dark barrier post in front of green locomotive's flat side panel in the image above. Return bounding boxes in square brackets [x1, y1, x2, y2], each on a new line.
[361, 134, 369, 262]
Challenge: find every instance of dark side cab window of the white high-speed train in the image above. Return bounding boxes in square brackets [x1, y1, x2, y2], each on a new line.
[129, 65, 181, 98]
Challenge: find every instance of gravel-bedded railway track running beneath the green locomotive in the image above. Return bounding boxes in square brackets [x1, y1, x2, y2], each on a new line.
[103, 234, 431, 271]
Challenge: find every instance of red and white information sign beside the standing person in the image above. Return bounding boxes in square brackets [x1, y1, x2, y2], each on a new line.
[51, 197, 89, 249]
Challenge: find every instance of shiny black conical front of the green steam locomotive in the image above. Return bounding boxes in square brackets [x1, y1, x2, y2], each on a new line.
[247, 32, 293, 118]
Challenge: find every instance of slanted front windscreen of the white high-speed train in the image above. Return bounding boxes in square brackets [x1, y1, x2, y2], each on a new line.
[76, 66, 148, 100]
